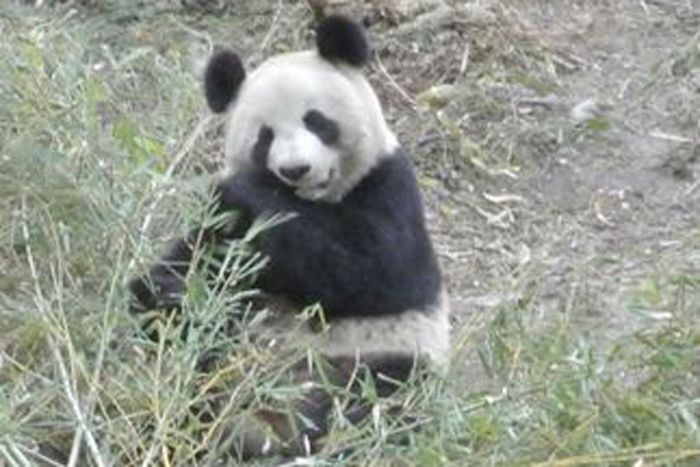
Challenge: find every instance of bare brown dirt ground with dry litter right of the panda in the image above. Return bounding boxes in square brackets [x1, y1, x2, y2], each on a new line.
[322, 0, 700, 384]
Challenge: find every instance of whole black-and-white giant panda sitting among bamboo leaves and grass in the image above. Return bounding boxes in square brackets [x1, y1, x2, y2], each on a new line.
[130, 16, 450, 456]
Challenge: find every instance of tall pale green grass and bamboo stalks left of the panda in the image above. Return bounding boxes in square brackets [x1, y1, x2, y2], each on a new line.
[0, 2, 260, 465]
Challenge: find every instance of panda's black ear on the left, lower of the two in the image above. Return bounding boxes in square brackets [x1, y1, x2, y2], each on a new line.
[204, 49, 245, 113]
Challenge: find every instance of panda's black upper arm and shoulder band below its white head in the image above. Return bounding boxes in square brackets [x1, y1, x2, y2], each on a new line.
[220, 154, 440, 318]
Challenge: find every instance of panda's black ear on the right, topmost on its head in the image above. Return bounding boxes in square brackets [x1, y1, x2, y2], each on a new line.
[316, 15, 370, 66]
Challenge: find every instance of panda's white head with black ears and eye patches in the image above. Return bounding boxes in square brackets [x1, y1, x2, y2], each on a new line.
[205, 16, 397, 202]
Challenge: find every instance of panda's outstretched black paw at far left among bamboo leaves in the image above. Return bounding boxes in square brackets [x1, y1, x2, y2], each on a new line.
[128, 267, 185, 314]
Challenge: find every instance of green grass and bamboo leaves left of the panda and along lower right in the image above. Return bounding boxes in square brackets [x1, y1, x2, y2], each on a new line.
[0, 3, 700, 466]
